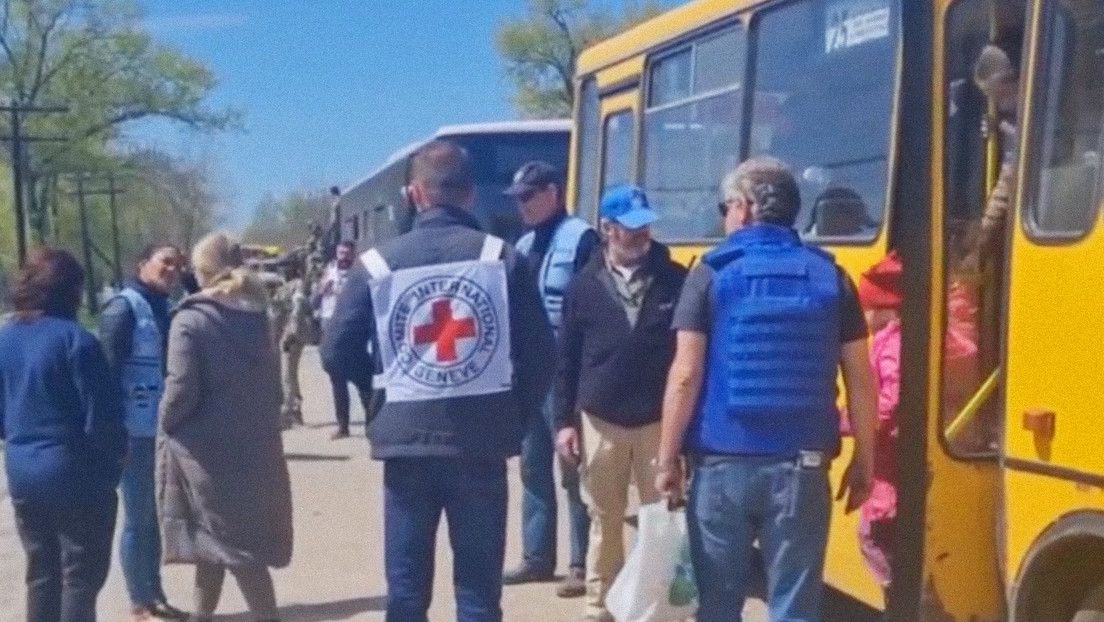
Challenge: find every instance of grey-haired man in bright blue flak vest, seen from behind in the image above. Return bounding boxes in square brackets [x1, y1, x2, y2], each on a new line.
[656, 157, 877, 622]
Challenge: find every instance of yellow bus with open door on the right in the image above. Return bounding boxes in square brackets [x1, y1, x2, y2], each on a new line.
[567, 0, 1104, 622]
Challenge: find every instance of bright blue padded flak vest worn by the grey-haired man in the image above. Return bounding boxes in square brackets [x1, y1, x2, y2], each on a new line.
[687, 224, 840, 455]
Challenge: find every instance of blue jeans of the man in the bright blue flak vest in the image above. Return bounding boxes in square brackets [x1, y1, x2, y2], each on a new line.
[687, 456, 831, 622]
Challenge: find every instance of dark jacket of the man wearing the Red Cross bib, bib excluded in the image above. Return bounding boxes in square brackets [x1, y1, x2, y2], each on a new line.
[321, 208, 554, 460]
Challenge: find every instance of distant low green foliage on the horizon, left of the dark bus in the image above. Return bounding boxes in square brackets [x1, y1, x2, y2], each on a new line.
[243, 189, 332, 251]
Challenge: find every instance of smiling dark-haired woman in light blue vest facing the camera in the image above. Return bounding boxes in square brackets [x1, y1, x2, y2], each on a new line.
[99, 244, 187, 622]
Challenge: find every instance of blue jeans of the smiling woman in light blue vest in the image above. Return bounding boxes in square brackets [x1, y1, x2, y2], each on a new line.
[119, 436, 164, 607]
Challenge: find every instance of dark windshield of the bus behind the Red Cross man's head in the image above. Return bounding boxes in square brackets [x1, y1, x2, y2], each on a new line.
[444, 131, 570, 243]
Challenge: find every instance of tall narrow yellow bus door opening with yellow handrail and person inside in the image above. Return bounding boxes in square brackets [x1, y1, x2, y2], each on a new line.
[942, 0, 1027, 456]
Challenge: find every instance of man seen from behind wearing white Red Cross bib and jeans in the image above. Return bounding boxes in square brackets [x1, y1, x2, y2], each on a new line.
[322, 140, 553, 622]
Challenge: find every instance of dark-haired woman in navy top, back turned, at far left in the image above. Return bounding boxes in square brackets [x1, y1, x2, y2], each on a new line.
[0, 250, 127, 622]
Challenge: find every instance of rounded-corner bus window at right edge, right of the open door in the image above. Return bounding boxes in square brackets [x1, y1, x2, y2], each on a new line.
[1025, 0, 1104, 239]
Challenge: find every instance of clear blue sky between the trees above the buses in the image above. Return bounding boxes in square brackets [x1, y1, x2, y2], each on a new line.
[129, 0, 671, 224]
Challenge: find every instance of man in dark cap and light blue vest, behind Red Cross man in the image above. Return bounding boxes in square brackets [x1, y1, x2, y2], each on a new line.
[502, 161, 601, 598]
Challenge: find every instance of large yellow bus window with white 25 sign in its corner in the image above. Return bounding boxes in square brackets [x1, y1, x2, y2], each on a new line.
[749, 0, 900, 241]
